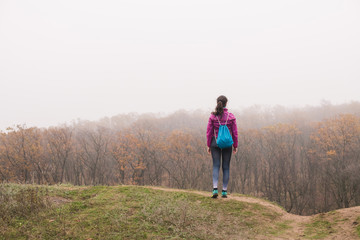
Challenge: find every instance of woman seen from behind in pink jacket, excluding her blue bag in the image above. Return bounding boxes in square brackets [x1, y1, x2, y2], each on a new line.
[206, 95, 238, 198]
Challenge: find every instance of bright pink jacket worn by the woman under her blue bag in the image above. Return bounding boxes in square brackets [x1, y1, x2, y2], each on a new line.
[206, 108, 238, 148]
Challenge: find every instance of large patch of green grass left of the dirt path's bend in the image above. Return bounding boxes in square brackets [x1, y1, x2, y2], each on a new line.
[0, 184, 289, 239]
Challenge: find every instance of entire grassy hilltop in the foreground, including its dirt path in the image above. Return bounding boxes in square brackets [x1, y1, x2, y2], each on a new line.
[0, 184, 360, 239]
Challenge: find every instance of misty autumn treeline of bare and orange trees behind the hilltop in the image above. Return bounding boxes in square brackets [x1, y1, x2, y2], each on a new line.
[0, 102, 360, 215]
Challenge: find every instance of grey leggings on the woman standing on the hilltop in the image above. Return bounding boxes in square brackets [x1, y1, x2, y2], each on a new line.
[210, 137, 232, 190]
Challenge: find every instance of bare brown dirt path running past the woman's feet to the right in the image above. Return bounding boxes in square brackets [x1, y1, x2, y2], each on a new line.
[149, 187, 360, 240]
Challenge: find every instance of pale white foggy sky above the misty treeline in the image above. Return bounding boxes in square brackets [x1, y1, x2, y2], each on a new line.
[0, 0, 360, 129]
